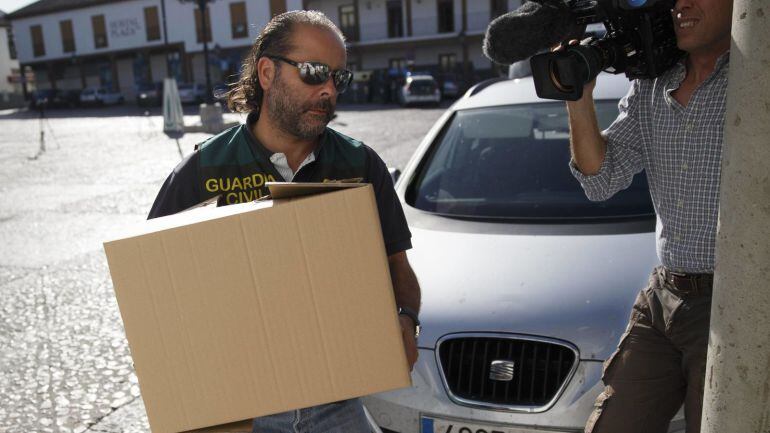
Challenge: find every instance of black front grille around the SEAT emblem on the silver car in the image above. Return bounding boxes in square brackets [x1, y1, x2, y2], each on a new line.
[439, 337, 576, 411]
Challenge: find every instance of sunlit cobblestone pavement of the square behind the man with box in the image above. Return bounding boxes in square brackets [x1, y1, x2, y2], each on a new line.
[0, 102, 443, 433]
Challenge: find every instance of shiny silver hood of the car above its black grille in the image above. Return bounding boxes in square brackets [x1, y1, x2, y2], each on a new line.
[408, 213, 658, 360]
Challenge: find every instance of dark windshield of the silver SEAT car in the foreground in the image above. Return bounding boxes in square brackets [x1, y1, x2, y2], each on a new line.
[406, 100, 654, 220]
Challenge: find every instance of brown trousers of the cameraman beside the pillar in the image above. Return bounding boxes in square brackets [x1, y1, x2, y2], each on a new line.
[585, 267, 711, 433]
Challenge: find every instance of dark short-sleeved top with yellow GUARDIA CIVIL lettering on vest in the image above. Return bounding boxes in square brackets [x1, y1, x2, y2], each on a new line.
[148, 116, 412, 255]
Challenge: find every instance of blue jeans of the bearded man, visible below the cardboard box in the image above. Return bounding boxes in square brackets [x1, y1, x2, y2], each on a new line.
[251, 398, 372, 433]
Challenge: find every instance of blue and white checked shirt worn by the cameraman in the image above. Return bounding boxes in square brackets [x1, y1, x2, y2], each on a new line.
[570, 52, 730, 273]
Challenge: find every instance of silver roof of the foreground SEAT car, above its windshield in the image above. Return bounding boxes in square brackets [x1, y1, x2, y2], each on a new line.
[453, 72, 631, 110]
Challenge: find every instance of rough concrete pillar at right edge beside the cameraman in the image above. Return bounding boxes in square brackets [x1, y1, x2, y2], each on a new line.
[701, 0, 770, 433]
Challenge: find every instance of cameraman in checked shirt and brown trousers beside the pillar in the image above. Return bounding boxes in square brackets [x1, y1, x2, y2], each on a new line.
[567, 0, 732, 433]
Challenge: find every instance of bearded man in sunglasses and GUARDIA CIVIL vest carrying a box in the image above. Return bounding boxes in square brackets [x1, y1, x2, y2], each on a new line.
[149, 11, 420, 433]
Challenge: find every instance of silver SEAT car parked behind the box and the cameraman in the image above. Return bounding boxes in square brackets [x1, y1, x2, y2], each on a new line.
[364, 74, 684, 433]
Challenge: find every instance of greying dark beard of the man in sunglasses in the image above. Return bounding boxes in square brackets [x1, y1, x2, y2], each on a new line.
[265, 76, 334, 140]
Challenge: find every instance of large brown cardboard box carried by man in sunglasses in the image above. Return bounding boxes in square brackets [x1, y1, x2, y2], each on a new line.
[104, 184, 411, 432]
